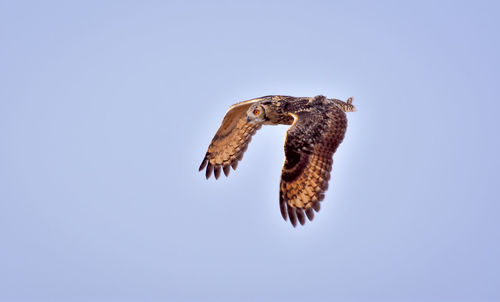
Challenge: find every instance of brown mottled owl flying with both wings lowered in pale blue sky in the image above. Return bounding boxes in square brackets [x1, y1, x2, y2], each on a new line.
[199, 95, 356, 227]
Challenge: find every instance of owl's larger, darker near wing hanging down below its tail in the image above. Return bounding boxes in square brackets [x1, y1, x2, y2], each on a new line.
[280, 106, 347, 227]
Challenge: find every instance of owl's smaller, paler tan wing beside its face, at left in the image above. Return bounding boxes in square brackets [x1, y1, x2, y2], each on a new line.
[199, 99, 261, 179]
